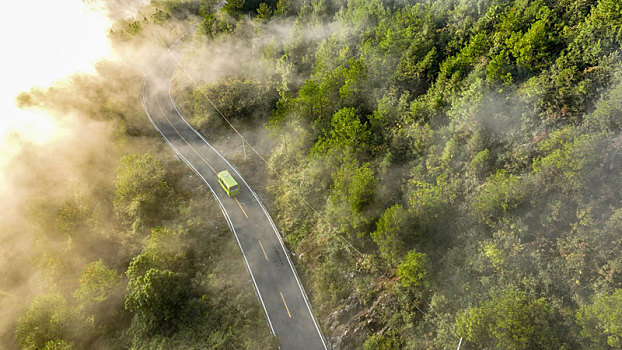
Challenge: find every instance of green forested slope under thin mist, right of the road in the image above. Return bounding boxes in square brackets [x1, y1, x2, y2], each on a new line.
[176, 0, 622, 349]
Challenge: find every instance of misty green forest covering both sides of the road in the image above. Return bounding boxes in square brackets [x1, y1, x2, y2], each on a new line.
[0, 0, 622, 350]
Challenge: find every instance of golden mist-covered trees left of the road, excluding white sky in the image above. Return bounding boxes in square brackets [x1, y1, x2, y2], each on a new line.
[0, 1, 275, 349]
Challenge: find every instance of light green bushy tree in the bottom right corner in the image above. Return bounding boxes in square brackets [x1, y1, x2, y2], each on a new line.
[576, 289, 622, 349]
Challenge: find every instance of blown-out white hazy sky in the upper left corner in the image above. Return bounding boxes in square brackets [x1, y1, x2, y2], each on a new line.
[0, 0, 111, 171]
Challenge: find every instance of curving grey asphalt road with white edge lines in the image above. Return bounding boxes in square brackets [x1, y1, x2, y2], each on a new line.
[141, 34, 328, 350]
